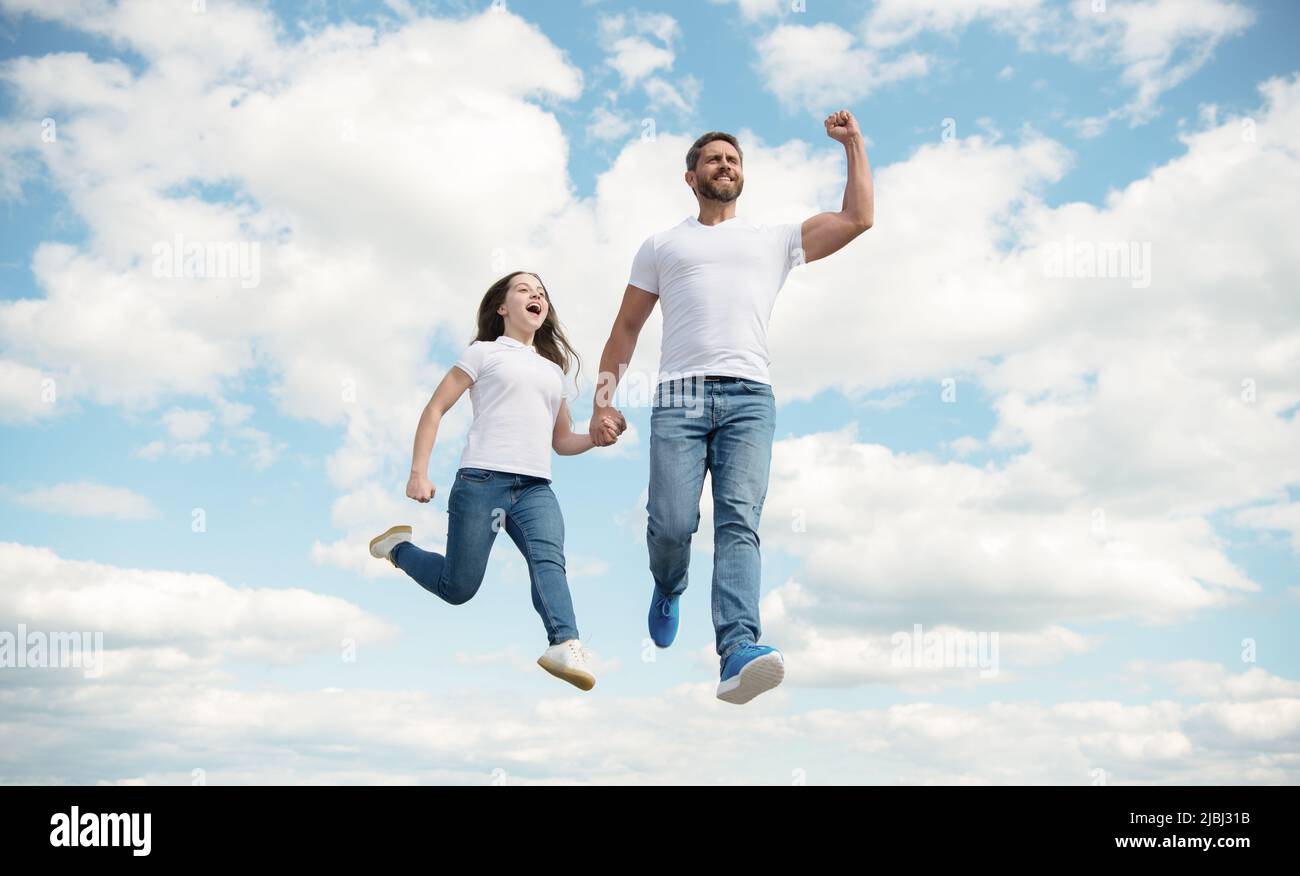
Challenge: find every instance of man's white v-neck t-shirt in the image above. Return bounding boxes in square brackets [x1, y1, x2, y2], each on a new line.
[628, 216, 803, 383]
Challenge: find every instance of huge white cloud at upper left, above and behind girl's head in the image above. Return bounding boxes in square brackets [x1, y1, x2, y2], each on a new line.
[0, 6, 580, 422]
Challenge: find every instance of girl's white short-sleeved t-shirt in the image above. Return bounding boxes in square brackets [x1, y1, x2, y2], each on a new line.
[455, 334, 564, 480]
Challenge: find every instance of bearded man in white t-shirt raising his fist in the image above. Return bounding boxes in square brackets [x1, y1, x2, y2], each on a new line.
[592, 110, 874, 703]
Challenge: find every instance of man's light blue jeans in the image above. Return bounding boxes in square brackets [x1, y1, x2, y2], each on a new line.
[646, 377, 776, 660]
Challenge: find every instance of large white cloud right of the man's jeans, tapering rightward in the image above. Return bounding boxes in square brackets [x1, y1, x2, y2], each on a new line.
[759, 429, 1258, 623]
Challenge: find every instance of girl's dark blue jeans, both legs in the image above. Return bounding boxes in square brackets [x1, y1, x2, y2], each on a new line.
[391, 468, 579, 645]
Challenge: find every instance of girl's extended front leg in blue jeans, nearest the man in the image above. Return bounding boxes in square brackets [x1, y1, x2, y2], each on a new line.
[506, 480, 579, 645]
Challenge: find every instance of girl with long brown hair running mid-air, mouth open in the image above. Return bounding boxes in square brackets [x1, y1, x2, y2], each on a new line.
[371, 272, 627, 690]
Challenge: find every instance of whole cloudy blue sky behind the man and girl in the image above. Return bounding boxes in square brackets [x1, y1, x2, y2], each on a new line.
[0, 0, 1300, 784]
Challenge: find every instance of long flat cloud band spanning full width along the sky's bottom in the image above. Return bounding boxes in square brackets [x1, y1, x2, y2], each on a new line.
[0, 644, 1300, 785]
